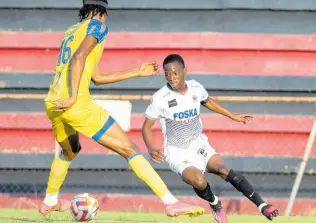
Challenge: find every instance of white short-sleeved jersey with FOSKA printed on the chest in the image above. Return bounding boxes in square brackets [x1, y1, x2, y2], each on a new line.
[145, 80, 208, 149]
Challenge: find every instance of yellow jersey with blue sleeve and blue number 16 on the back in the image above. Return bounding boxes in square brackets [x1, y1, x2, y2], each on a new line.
[45, 19, 108, 101]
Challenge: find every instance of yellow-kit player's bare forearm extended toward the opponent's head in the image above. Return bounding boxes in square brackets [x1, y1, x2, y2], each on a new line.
[92, 62, 159, 85]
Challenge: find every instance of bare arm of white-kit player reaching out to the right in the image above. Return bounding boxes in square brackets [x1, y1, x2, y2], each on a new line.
[201, 97, 253, 124]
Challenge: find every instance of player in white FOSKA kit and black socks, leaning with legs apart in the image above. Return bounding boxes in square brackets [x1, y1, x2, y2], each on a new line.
[142, 54, 278, 223]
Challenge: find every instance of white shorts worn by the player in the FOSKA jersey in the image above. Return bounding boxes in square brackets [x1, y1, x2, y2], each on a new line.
[164, 134, 218, 176]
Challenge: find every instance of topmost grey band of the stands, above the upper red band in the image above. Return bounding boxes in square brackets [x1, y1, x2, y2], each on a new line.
[0, 0, 316, 34]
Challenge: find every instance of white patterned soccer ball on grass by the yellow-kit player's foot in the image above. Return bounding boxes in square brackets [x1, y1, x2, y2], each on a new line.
[70, 193, 99, 221]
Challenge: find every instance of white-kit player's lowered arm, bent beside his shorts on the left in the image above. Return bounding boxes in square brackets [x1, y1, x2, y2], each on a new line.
[142, 118, 163, 163]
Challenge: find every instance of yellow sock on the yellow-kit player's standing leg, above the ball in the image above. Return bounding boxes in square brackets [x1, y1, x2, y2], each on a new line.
[44, 154, 71, 206]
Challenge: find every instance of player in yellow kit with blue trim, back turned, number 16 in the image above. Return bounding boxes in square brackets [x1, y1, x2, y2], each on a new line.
[39, 0, 204, 216]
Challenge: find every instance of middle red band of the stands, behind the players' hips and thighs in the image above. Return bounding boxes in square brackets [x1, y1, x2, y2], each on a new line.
[0, 113, 316, 157]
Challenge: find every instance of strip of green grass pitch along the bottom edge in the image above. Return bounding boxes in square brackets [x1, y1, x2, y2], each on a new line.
[0, 209, 316, 223]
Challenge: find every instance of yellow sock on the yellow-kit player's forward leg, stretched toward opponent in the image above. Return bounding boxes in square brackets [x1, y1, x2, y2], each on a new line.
[128, 153, 178, 204]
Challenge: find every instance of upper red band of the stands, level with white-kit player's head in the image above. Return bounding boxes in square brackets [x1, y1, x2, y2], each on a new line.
[0, 32, 316, 76]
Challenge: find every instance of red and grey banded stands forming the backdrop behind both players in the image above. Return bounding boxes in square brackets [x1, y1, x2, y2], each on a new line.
[0, 0, 316, 220]
